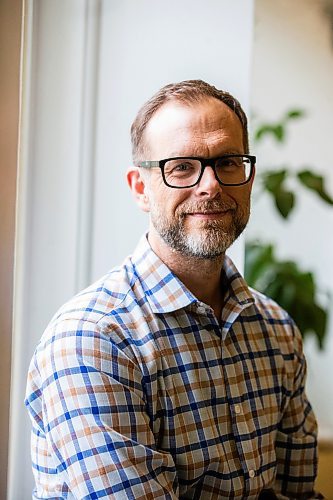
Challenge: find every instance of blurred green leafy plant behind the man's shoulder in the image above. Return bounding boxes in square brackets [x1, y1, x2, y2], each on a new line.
[245, 109, 333, 348]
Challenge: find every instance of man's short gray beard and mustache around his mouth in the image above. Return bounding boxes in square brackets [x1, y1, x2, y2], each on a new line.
[151, 202, 249, 260]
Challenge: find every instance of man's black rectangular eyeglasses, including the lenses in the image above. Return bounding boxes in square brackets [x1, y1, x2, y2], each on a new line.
[139, 154, 256, 189]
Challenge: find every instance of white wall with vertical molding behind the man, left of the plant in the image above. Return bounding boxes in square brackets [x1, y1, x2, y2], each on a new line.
[8, 0, 253, 500]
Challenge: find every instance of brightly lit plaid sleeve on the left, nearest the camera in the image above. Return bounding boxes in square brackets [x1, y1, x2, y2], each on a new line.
[27, 320, 178, 500]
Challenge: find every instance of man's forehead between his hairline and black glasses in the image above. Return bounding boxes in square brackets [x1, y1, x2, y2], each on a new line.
[144, 97, 243, 159]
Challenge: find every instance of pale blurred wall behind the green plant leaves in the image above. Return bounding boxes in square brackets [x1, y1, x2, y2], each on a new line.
[247, 0, 333, 439]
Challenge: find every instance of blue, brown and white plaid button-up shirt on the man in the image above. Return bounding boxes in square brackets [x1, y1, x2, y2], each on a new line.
[26, 237, 317, 500]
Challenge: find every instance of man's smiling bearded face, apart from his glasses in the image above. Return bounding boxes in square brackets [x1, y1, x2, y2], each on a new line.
[139, 98, 252, 259]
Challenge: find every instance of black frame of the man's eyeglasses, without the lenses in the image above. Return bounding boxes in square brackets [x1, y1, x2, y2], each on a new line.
[138, 154, 257, 189]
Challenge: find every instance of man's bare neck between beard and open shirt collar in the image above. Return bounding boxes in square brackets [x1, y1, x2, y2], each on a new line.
[148, 232, 224, 318]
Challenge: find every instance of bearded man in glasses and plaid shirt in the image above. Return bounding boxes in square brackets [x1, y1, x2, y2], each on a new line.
[26, 80, 318, 499]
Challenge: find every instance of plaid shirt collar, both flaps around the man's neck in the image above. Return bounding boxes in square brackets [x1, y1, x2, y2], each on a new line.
[131, 234, 254, 313]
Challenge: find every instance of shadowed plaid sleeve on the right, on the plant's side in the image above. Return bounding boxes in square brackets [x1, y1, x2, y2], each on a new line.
[274, 325, 324, 500]
